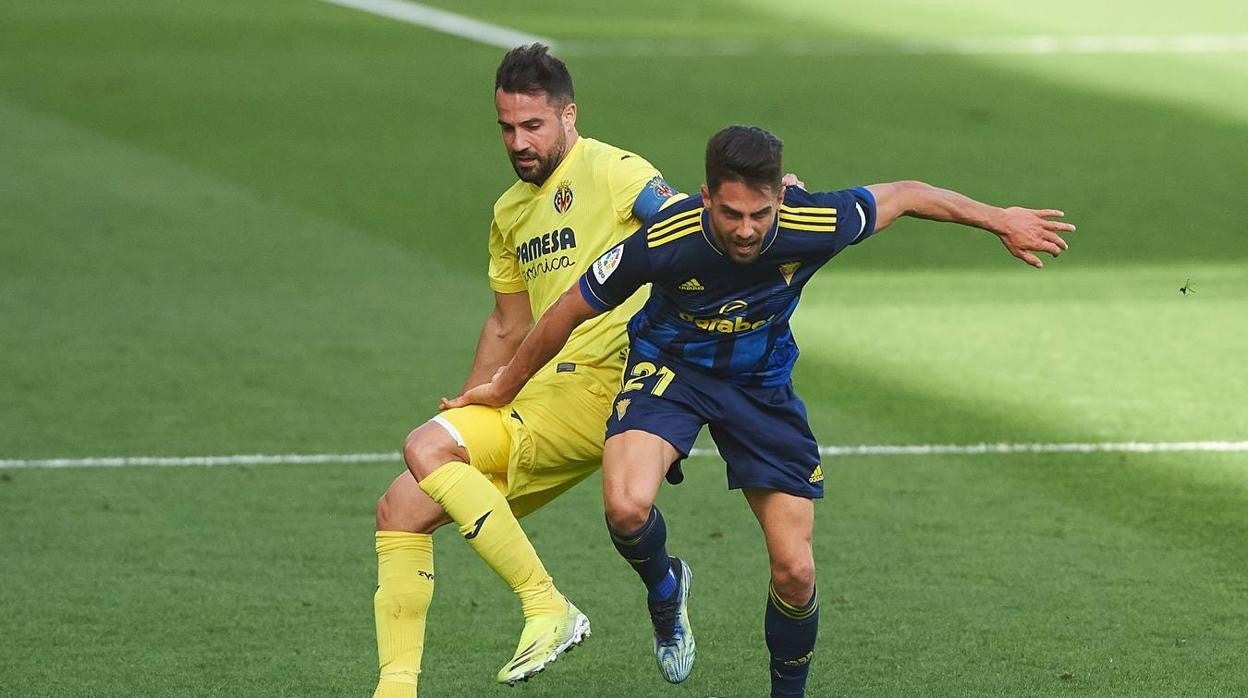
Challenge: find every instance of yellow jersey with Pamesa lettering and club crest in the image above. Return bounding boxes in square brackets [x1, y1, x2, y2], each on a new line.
[489, 136, 660, 371]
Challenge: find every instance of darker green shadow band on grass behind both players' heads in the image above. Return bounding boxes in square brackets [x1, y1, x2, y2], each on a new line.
[0, 2, 1248, 273]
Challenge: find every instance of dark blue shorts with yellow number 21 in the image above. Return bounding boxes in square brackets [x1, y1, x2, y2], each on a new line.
[607, 357, 824, 499]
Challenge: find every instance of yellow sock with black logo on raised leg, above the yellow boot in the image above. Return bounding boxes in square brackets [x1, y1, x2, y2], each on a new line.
[421, 461, 565, 618]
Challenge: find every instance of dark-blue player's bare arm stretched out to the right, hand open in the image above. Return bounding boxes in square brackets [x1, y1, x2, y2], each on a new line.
[866, 181, 1075, 268]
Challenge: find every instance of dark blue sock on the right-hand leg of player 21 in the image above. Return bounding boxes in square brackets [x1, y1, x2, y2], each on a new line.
[764, 587, 819, 698]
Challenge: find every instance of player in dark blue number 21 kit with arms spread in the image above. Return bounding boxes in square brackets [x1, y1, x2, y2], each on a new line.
[452, 126, 1075, 697]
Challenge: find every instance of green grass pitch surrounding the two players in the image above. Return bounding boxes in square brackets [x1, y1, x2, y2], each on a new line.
[0, 0, 1248, 697]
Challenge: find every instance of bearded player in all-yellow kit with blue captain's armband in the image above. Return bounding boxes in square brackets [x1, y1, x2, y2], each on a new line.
[374, 44, 674, 698]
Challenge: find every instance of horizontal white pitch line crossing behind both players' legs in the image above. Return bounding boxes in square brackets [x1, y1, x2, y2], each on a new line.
[0, 441, 1248, 469]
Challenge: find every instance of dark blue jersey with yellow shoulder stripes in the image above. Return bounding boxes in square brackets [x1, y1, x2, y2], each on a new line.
[579, 186, 875, 386]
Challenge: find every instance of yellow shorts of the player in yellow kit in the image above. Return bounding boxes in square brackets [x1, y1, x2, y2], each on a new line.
[434, 365, 622, 517]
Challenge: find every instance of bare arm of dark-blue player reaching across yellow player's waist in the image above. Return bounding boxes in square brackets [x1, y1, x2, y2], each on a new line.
[441, 285, 603, 410]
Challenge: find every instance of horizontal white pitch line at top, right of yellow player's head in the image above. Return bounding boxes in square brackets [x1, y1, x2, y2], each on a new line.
[559, 34, 1248, 57]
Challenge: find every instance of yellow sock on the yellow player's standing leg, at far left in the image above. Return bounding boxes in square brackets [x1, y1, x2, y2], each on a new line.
[373, 531, 433, 698]
